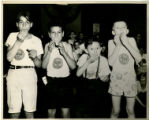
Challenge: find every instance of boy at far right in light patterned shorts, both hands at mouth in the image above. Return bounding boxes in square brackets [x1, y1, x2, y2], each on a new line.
[108, 21, 141, 118]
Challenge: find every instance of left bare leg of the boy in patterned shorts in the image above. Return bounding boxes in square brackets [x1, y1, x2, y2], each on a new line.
[111, 96, 121, 118]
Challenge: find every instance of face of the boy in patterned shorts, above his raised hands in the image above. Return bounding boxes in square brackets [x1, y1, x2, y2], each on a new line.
[113, 22, 128, 35]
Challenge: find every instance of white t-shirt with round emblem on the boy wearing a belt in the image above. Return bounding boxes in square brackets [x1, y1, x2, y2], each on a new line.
[5, 32, 43, 66]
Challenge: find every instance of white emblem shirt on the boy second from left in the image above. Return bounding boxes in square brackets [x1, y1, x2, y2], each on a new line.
[45, 42, 74, 78]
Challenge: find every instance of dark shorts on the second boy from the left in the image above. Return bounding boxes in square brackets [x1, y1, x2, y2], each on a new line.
[46, 77, 73, 109]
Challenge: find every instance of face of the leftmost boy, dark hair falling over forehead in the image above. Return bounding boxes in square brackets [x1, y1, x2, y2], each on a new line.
[16, 16, 33, 32]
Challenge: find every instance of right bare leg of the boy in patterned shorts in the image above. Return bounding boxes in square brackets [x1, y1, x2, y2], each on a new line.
[126, 97, 135, 118]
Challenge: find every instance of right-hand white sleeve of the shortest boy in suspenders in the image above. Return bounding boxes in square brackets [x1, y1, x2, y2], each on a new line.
[98, 57, 111, 77]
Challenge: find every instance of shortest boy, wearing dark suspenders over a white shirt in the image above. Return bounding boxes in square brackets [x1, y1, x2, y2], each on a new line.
[76, 38, 110, 117]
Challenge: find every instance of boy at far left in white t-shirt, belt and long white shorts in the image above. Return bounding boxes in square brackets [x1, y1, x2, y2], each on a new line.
[5, 12, 43, 118]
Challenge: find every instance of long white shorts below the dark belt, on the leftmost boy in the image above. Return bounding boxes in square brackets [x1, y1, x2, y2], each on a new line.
[6, 68, 37, 113]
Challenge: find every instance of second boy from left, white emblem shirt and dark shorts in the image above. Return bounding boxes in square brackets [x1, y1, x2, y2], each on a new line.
[42, 24, 76, 118]
